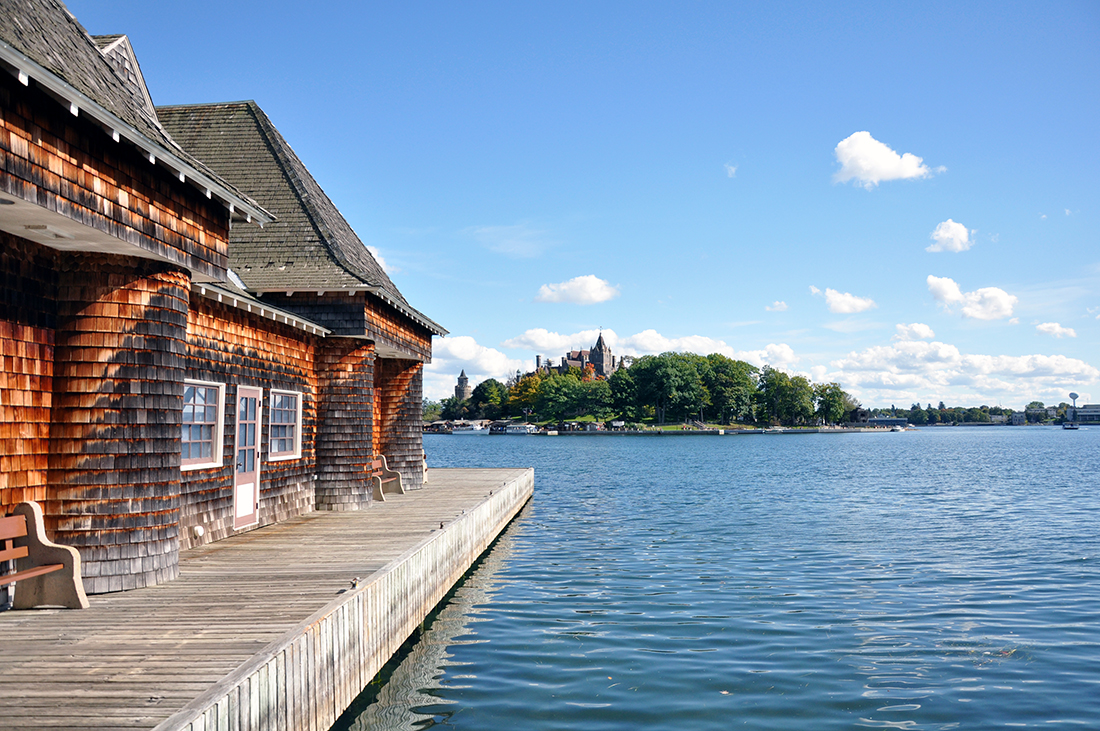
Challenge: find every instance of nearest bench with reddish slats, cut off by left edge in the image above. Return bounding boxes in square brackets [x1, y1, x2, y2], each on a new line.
[0, 502, 88, 609]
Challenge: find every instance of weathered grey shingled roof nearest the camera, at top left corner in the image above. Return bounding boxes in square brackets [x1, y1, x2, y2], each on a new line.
[0, 0, 270, 223]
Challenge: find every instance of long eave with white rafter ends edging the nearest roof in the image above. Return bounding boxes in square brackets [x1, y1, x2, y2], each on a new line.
[0, 41, 275, 226]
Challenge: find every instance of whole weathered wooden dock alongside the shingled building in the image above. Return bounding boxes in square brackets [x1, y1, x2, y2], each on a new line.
[0, 469, 535, 731]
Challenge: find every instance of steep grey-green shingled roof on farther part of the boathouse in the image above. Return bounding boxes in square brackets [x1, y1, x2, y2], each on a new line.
[156, 101, 446, 334]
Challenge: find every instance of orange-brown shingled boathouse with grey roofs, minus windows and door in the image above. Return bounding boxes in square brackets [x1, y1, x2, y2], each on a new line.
[0, 0, 444, 592]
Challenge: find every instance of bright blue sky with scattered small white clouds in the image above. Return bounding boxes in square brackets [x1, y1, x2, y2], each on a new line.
[68, 0, 1100, 408]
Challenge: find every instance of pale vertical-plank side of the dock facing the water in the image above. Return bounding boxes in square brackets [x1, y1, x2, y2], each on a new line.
[154, 468, 535, 731]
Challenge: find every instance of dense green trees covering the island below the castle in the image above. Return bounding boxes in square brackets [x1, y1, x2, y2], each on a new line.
[425, 353, 859, 427]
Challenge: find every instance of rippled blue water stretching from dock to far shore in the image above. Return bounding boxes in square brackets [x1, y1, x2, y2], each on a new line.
[343, 428, 1100, 731]
